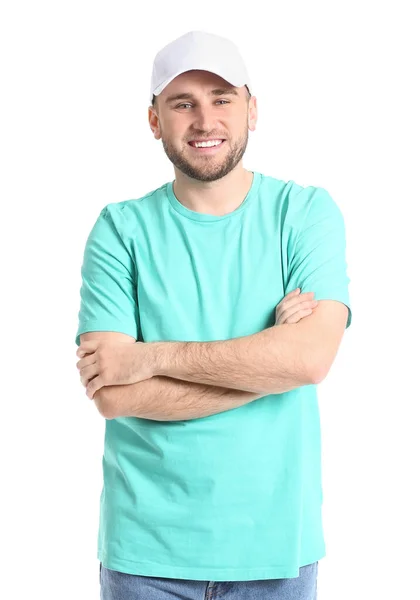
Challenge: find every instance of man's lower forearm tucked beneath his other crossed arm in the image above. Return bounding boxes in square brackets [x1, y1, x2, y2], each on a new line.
[96, 376, 262, 421]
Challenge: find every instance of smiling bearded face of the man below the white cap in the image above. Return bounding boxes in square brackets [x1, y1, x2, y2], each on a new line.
[149, 71, 257, 181]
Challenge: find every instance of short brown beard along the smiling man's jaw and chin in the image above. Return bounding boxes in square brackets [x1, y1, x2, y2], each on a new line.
[162, 126, 248, 181]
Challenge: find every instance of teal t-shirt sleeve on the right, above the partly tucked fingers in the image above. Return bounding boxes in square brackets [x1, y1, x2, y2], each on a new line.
[286, 186, 352, 329]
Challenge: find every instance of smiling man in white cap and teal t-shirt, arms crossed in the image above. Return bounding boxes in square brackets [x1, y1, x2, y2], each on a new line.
[76, 31, 351, 600]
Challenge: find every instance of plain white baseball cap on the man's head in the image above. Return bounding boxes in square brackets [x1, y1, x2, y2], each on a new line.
[150, 31, 252, 103]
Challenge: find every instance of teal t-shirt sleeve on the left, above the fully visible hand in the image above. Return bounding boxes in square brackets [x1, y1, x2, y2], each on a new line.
[76, 203, 139, 346]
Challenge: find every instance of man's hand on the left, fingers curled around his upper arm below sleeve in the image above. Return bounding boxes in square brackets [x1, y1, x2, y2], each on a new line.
[76, 340, 154, 399]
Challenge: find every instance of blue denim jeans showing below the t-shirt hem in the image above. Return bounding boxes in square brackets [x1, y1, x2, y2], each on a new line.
[99, 561, 318, 600]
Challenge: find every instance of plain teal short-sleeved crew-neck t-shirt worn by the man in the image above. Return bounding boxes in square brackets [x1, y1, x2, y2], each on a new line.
[76, 172, 351, 581]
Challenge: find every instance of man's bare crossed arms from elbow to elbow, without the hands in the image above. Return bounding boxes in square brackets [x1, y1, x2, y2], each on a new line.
[79, 300, 348, 421]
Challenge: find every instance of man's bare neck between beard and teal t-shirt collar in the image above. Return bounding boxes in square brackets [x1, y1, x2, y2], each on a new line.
[173, 165, 253, 216]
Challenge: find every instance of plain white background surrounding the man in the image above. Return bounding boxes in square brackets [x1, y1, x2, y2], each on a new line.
[0, 0, 420, 600]
